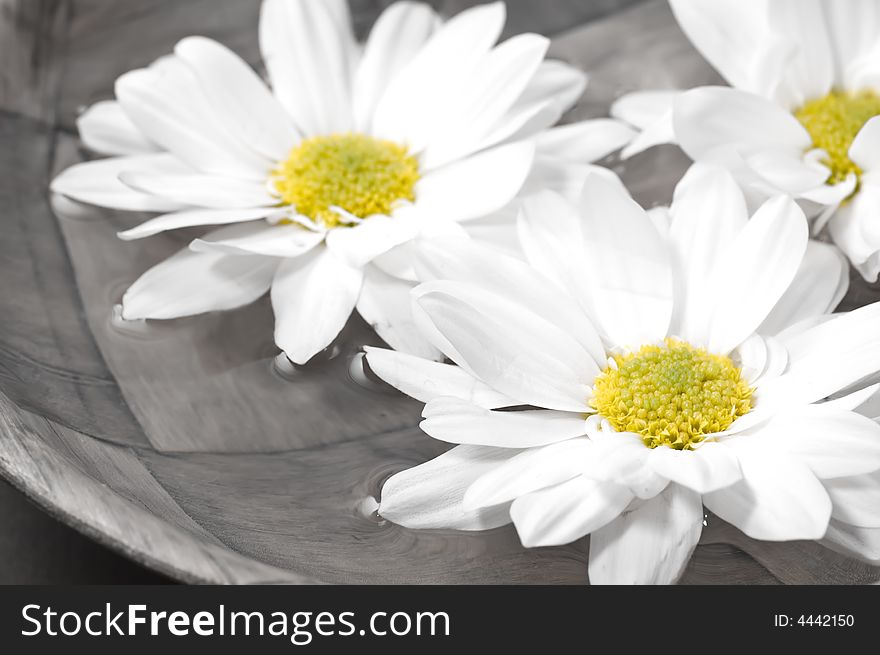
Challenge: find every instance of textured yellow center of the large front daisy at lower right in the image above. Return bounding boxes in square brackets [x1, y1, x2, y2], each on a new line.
[592, 339, 753, 450]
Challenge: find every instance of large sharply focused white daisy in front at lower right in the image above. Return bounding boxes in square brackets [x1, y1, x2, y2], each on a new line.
[367, 165, 880, 583]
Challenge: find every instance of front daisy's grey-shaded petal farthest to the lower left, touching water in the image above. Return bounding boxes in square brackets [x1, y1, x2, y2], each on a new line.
[379, 446, 518, 530]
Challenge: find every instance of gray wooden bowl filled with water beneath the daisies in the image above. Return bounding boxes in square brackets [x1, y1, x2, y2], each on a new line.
[0, 0, 880, 583]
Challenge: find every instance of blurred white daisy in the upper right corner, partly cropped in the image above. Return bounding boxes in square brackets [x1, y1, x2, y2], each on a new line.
[612, 0, 880, 281]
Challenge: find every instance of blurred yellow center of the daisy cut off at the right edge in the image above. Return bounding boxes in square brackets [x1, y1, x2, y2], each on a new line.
[794, 90, 880, 184]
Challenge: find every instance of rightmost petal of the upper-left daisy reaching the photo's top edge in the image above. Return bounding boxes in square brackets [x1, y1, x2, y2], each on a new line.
[372, 2, 506, 152]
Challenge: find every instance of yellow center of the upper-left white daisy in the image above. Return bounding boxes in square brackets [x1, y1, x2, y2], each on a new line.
[271, 133, 419, 228]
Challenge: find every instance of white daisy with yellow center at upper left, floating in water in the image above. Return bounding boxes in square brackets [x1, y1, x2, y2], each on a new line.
[52, 0, 633, 363]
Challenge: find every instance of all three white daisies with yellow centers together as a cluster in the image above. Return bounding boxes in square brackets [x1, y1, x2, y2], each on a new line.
[52, 0, 880, 583]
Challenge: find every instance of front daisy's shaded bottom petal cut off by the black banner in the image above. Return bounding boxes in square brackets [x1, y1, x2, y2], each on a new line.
[590, 484, 703, 585]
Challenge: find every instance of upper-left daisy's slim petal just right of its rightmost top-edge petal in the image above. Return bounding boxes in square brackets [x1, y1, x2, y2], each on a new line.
[421, 34, 550, 170]
